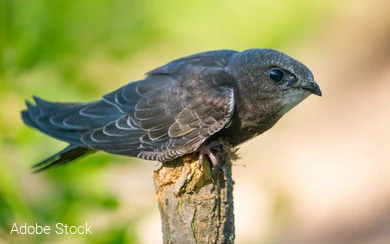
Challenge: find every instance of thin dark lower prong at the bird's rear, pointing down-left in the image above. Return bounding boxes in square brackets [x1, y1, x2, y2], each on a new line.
[32, 145, 94, 173]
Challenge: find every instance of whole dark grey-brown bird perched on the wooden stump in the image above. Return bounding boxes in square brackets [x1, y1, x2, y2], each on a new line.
[21, 48, 322, 172]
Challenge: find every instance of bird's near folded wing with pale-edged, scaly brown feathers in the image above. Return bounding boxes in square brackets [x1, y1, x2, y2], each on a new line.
[82, 65, 234, 161]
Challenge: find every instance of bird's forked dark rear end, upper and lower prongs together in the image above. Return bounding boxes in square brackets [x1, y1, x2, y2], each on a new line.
[21, 96, 116, 172]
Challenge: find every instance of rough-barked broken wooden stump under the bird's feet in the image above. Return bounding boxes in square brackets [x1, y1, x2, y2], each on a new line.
[154, 142, 237, 244]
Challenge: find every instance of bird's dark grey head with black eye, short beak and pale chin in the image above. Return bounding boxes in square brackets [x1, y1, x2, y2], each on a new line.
[229, 49, 322, 115]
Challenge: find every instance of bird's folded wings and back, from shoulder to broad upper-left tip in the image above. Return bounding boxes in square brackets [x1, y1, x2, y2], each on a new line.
[23, 51, 235, 161]
